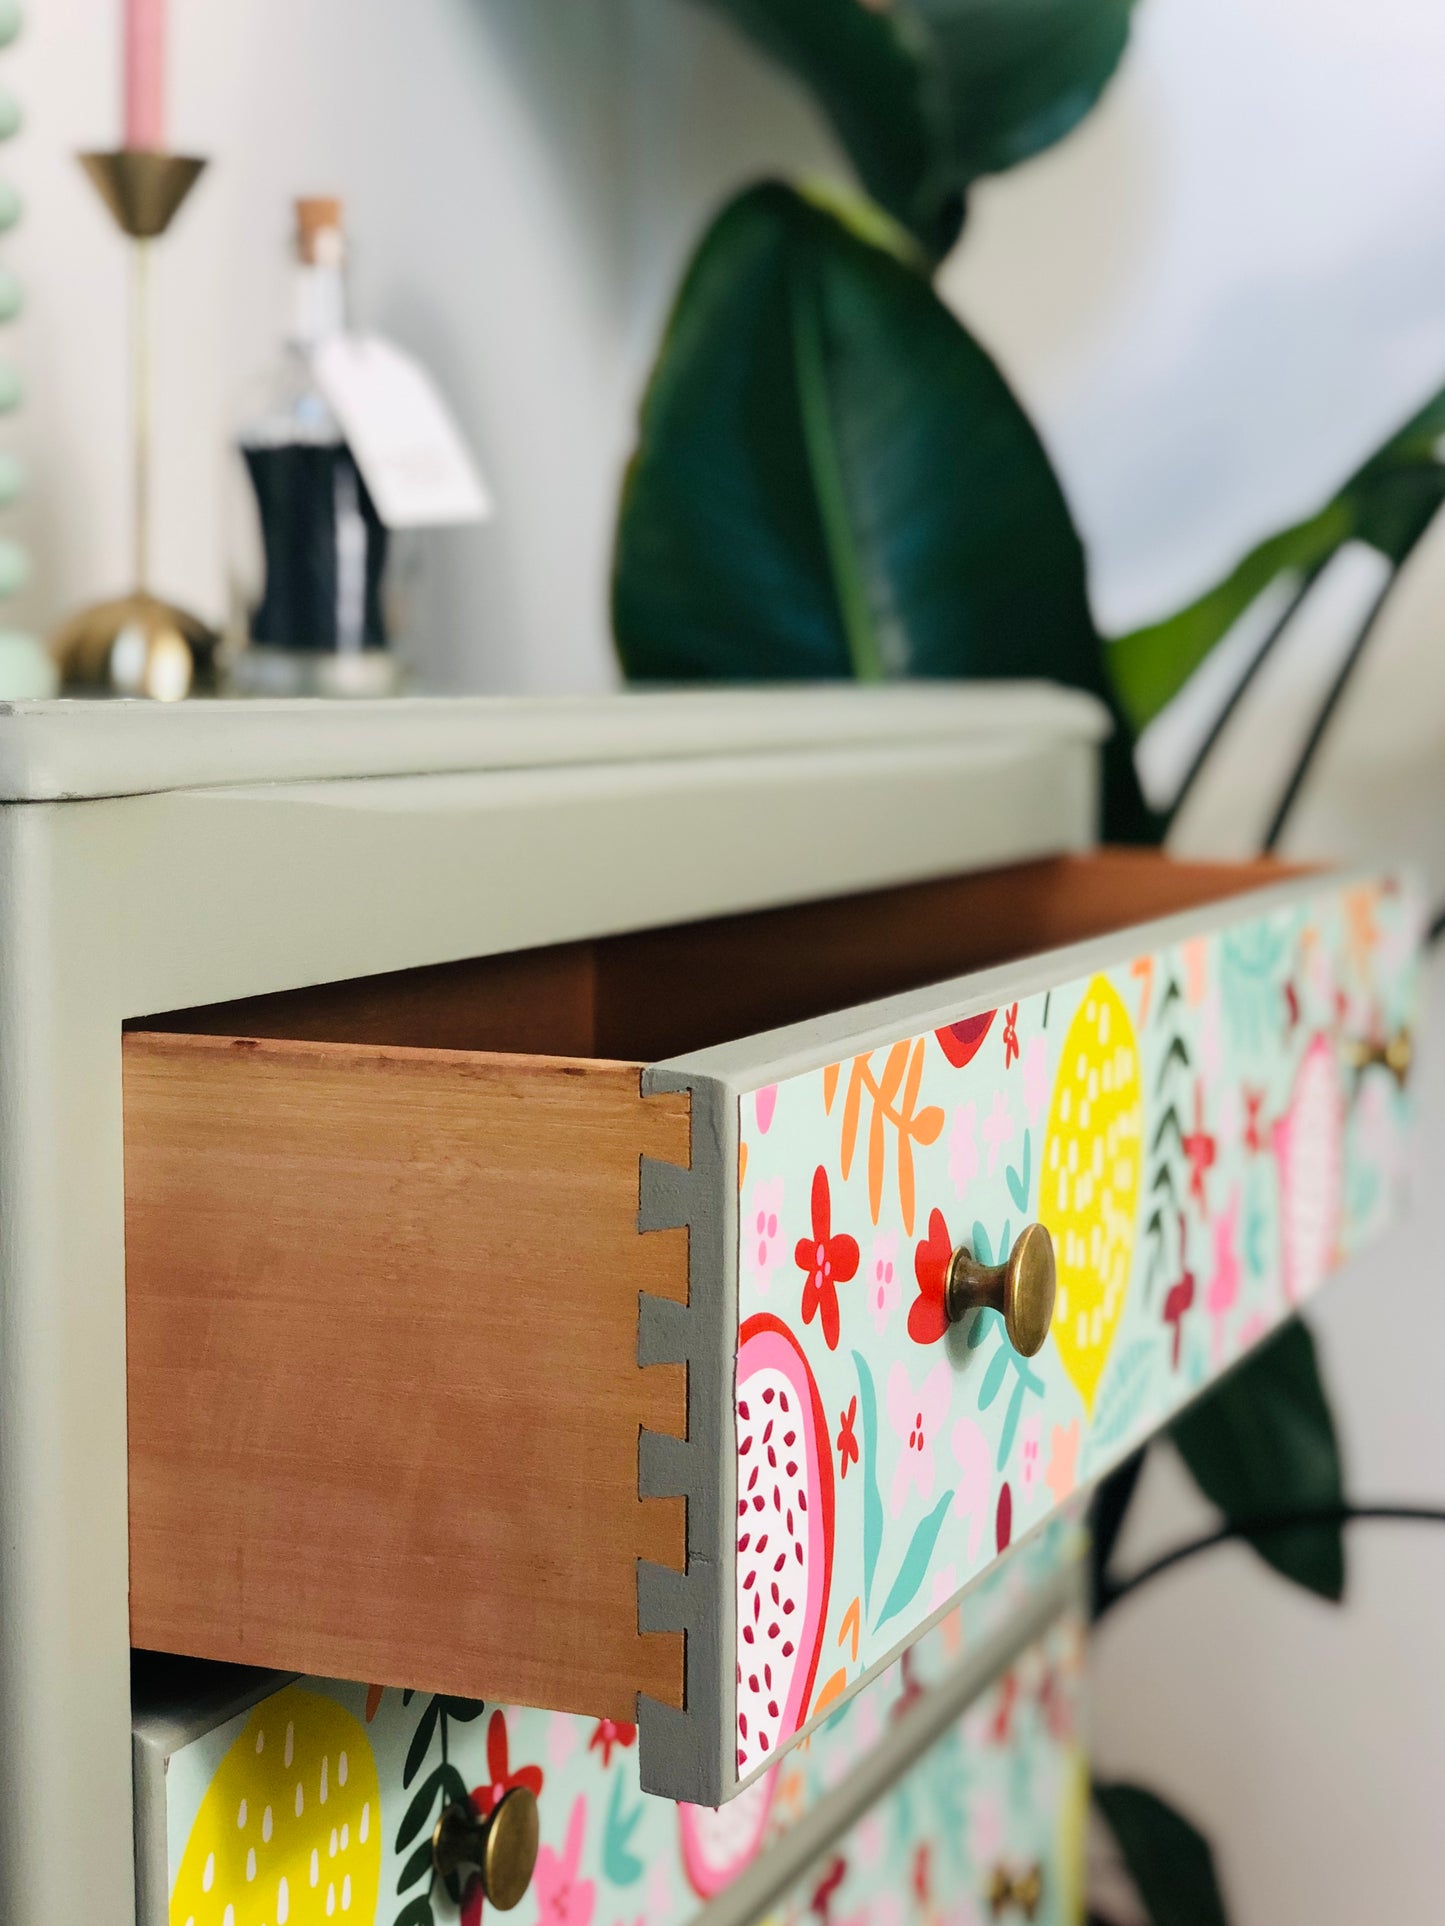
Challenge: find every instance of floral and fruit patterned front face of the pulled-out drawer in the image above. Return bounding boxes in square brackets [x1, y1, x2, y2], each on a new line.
[736, 882, 1420, 1782]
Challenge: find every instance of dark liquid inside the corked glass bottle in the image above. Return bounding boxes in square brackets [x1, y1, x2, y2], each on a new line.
[241, 441, 387, 651]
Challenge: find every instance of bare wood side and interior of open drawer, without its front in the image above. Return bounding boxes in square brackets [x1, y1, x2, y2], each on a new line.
[123, 853, 1285, 1720]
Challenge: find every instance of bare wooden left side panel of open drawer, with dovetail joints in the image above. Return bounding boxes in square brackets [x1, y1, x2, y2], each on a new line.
[125, 1034, 688, 1720]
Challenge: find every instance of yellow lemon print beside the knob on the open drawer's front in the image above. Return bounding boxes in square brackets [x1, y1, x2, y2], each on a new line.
[1038, 976, 1144, 1416]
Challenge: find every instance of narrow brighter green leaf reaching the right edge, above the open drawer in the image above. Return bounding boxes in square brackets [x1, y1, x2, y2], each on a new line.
[1108, 389, 1445, 730]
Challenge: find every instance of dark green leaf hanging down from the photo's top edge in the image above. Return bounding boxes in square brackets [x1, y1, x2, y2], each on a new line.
[703, 0, 1133, 254]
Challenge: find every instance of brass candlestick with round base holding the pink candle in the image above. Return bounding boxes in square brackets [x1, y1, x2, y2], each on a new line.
[50, 148, 220, 701]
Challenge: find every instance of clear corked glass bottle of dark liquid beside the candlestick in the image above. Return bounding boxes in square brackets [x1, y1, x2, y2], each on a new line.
[229, 198, 401, 695]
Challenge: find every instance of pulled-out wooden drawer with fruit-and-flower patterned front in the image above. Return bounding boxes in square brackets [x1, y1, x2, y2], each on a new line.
[125, 853, 1418, 1805]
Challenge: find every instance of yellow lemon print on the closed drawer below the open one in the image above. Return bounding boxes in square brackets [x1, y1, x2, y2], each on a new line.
[171, 1685, 381, 1926]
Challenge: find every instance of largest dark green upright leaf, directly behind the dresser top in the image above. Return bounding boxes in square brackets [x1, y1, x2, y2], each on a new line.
[613, 183, 1148, 840]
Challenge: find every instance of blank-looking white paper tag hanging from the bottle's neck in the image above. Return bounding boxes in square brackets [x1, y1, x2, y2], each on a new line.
[314, 335, 493, 528]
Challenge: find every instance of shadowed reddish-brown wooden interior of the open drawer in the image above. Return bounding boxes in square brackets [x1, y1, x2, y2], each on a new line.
[129, 849, 1301, 1063]
